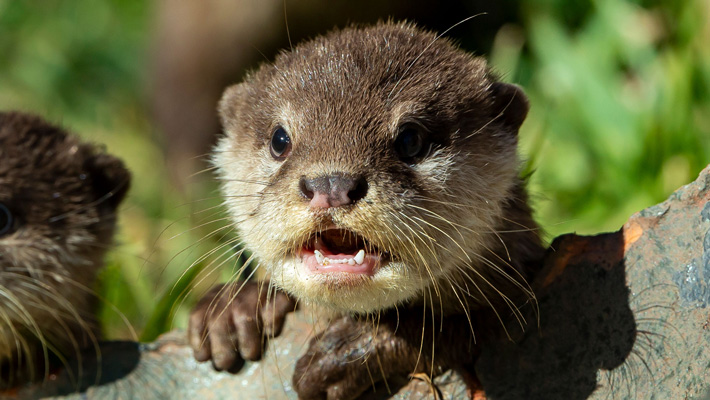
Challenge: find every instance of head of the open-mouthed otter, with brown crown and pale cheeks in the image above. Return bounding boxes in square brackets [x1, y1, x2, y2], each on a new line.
[214, 24, 528, 313]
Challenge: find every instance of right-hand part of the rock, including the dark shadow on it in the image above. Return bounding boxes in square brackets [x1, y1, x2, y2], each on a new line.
[476, 167, 710, 400]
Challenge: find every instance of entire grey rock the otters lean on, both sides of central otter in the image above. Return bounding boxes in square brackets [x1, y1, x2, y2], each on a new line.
[5, 167, 710, 400]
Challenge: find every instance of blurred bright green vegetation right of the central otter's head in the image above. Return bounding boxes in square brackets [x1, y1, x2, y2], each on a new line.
[508, 0, 710, 236]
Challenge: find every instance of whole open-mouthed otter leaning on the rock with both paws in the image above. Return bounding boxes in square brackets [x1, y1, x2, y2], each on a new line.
[188, 22, 544, 399]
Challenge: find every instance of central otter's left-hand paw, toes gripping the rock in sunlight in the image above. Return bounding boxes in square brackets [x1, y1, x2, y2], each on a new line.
[187, 282, 296, 370]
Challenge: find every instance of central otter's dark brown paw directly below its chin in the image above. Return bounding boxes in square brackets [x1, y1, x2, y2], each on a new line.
[293, 317, 426, 400]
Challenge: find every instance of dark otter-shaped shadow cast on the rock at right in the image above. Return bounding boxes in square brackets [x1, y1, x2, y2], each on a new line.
[476, 231, 636, 400]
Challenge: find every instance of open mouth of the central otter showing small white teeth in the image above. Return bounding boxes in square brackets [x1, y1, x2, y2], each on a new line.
[300, 228, 388, 276]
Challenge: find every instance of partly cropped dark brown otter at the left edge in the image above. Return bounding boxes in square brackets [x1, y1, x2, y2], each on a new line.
[0, 112, 130, 388]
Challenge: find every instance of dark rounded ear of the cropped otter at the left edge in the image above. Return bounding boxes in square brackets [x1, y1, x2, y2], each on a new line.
[84, 153, 131, 212]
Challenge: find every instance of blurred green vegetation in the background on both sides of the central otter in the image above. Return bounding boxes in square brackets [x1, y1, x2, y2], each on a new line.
[0, 0, 710, 340]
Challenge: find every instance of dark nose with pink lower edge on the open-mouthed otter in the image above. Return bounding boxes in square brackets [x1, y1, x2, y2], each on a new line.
[299, 174, 367, 208]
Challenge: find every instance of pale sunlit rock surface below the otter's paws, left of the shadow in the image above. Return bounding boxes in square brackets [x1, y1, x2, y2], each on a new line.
[7, 313, 466, 400]
